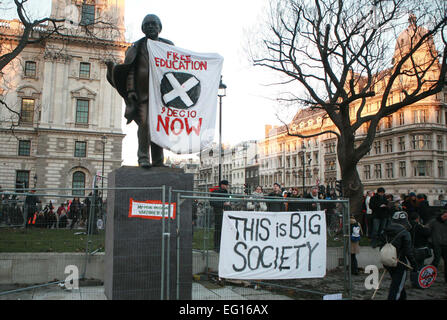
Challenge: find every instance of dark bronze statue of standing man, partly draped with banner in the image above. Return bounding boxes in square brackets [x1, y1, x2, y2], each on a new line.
[107, 14, 174, 168]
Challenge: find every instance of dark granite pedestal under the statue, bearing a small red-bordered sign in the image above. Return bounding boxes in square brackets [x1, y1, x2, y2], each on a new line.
[104, 167, 193, 300]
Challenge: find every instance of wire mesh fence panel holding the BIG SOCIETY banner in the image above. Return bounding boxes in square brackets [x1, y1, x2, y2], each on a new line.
[181, 192, 352, 300]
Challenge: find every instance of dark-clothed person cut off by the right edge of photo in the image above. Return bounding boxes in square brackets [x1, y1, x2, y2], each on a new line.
[428, 209, 447, 282]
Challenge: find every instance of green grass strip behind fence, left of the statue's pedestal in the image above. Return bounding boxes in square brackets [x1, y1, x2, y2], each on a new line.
[0, 228, 105, 252]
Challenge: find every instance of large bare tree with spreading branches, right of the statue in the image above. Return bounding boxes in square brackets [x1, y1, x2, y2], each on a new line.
[252, 0, 447, 212]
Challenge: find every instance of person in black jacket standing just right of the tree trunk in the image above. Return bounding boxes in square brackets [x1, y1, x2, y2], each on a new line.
[369, 188, 390, 248]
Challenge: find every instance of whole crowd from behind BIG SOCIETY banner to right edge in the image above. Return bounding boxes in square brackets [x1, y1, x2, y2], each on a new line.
[210, 180, 447, 299]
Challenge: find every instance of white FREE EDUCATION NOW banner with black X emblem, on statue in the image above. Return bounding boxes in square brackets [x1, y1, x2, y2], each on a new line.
[147, 40, 223, 154]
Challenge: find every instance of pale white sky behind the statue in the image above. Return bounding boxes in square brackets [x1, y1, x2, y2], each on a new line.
[6, 0, 288, 165]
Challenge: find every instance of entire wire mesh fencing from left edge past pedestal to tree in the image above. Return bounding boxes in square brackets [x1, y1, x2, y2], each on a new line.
[0, 186, 351, 300]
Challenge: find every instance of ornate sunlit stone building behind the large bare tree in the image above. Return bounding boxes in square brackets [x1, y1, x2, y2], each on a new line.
[259, 20, 447, 203]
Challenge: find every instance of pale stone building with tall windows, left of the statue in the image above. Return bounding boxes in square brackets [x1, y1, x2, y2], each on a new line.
[0, 0, 129, 196]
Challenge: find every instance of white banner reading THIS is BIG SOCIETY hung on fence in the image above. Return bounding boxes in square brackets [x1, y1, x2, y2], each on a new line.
[219, 211, 326, 279]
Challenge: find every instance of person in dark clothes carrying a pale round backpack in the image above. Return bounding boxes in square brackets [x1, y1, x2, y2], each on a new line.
[378, 211, 419, 300]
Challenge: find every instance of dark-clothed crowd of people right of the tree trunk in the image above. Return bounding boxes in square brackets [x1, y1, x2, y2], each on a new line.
[360, 188, 447, 300]
